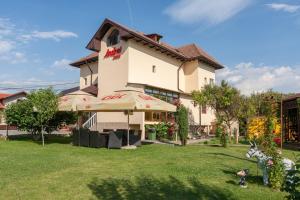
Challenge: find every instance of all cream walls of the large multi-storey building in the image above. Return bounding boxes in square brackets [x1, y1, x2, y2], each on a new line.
[80, 28, 220, 138]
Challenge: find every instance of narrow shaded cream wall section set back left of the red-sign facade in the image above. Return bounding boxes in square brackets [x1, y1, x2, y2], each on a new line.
[80, 62, 98, 89]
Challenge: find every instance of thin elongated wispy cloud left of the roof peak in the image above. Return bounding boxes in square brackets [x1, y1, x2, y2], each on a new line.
[21, 30, 78, 41]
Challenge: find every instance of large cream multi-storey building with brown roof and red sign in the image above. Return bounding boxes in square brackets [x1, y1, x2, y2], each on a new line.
[71, 19, 223, 138]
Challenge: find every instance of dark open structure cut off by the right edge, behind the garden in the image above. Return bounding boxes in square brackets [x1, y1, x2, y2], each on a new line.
[282, 93, 300, 142]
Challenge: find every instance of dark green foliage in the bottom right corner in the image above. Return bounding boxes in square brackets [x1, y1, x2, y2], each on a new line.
[284, 156, 300, 200]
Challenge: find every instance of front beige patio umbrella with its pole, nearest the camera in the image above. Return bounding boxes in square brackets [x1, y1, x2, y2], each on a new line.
[77, 90, 176, 146]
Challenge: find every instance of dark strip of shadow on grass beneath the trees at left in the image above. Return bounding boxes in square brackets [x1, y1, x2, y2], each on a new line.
[8, 134, 72, 144]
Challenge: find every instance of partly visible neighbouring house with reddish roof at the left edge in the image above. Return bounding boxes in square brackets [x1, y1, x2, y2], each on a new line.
[0, 92, 27, 125]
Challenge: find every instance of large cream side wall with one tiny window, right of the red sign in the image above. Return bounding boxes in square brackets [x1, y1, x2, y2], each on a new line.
[128, 40, 181, 91]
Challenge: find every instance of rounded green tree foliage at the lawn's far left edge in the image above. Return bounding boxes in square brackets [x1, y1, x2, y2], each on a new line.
[5, 88, 58, 133]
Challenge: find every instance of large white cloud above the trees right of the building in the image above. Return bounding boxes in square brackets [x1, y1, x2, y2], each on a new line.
[216, 62, 300, 95]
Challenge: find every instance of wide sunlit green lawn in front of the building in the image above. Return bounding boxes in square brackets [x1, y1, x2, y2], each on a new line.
[0, 137, 293, 200]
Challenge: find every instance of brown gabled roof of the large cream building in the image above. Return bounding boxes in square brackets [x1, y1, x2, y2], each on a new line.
[71, 19, 224, 69]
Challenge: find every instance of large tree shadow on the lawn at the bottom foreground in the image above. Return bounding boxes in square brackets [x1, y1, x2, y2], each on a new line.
[88, 176, 234, 200]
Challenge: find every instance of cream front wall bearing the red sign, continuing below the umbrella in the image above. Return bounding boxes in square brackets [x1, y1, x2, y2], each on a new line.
[97, 28, 144, 136]
